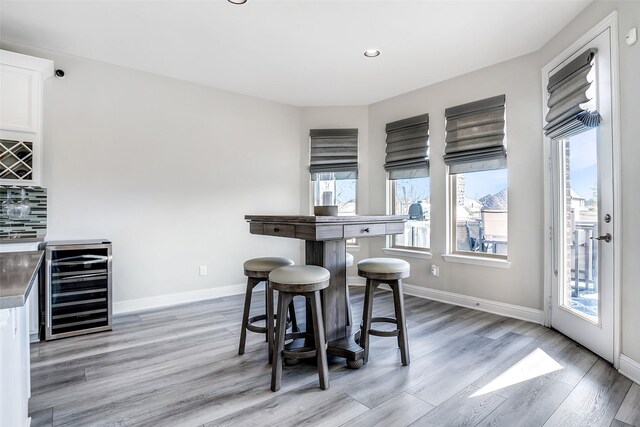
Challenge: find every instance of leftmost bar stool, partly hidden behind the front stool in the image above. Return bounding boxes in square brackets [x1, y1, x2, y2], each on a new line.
[238, 257, 298, 362]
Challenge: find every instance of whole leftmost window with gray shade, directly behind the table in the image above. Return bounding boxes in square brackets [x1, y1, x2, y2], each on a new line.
[309, 129, 358, 215]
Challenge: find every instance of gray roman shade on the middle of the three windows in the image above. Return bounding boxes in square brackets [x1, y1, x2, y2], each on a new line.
[384, 114, 429, 179]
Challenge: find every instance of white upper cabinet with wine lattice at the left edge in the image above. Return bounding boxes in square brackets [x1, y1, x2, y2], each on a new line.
[0, 50, 53, 186]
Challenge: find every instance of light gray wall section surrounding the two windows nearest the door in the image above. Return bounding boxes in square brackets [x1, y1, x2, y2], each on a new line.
[369, 54, 543, 309]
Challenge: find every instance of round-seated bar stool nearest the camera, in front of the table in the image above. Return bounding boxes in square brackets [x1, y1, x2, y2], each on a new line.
[269, 265, 330, 391]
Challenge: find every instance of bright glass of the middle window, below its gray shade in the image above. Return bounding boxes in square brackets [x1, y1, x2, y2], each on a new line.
[389, 176, 431, 250]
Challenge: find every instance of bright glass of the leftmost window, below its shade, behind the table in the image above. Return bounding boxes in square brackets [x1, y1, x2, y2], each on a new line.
[313, 172, 358, 215]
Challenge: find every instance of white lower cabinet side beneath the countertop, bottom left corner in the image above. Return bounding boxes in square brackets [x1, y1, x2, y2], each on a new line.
[0, 307, 31, 427]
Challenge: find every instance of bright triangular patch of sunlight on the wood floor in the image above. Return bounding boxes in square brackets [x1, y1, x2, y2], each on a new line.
[469, 348, 563, 397]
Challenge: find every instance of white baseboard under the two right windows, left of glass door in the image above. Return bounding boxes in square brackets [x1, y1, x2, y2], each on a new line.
[348, 277, 543, 325]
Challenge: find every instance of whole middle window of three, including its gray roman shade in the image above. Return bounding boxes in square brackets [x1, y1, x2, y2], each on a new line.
[384, 114, 431, 251]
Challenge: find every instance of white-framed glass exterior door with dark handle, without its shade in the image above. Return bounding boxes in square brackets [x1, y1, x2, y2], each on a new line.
[549, 29, 616, 362]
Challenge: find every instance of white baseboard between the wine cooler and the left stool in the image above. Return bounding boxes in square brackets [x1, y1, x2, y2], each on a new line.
[113, 283, 247, 314]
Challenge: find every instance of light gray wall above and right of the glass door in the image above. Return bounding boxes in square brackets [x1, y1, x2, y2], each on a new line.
[540, 1, 640, 370]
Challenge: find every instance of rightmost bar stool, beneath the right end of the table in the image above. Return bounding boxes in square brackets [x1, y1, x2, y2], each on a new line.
[358, 258, 410, 366]
